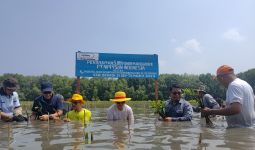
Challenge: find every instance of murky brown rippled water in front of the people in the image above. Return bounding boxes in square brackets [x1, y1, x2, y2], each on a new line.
[0, 107, 255, 150]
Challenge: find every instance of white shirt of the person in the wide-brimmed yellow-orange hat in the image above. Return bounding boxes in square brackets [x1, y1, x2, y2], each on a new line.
[107, 104, 134, 124]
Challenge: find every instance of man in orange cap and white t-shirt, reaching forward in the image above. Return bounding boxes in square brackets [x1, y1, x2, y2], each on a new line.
[201, 65, 255, 127]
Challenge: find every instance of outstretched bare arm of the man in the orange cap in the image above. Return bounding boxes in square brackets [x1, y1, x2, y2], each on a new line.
[201, 102, 241, 116]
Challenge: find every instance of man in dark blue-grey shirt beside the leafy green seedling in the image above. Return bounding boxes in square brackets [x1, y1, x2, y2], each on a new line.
[163, 84, 193, 121]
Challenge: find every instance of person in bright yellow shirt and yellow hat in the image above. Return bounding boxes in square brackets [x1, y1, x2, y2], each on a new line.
[64, 94, 91, 124]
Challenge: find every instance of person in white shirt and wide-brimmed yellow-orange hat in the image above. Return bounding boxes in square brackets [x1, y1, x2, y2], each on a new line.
[107, 91, 134, 124]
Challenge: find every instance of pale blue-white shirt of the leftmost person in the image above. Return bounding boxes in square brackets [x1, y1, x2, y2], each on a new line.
[0, 92, 20, 116]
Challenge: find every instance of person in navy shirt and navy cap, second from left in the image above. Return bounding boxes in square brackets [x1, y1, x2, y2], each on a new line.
[32, 82, 64, 121]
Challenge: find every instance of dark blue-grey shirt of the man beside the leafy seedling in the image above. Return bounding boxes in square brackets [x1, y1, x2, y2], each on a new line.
[165, 99, 193, 121]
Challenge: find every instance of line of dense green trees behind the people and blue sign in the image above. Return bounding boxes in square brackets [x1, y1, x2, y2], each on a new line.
[0, 69, 255, 101]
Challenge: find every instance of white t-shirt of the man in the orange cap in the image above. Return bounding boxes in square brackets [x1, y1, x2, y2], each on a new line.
[226, 78, 255, 127]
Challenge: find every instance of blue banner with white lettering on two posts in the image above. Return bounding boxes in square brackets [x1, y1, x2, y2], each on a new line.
[75, 52, 159, 79]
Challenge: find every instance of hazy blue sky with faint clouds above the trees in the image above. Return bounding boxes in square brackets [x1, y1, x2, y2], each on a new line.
[0, 0, 255, 77]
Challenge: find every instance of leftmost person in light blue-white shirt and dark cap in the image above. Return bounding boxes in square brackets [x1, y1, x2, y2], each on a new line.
[0, 78, 27, 122]
